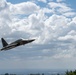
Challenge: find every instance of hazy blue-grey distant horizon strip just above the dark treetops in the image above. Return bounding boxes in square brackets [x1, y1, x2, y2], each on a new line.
[0, 69, 67, 74]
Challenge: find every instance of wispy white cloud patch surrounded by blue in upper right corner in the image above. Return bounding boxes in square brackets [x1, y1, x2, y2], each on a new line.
[48, 2, 75, 17]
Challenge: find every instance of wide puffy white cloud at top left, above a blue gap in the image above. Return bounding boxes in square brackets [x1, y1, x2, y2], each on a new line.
[10, 2, 39, 14]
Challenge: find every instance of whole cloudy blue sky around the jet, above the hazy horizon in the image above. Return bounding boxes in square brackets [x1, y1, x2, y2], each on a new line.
[0, 0, 76, 72]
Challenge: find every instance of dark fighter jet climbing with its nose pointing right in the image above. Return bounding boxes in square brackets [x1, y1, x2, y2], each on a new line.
[0, 38, 35, 51]
